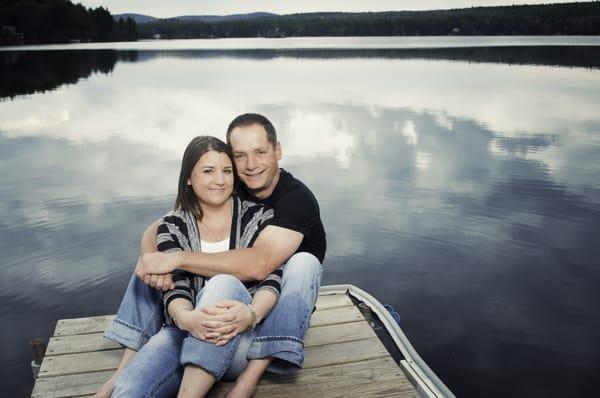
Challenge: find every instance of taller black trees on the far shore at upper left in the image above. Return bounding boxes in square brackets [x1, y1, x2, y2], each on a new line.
[0, 0, 138, 44]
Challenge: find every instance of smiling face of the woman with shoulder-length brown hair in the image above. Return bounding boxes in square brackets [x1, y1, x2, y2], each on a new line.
[187, 151, 233, 206]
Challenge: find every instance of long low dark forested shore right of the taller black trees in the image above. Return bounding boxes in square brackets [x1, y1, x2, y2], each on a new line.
[138, 1, 600, 38]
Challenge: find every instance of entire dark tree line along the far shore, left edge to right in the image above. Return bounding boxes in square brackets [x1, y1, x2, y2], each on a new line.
[0, 0, 600, 45]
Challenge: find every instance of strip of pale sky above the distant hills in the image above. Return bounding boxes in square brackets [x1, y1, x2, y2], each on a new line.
[73, 0, 575, 18]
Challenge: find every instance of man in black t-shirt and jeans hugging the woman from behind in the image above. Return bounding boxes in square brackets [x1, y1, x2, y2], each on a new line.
[99, 113, 326, 396]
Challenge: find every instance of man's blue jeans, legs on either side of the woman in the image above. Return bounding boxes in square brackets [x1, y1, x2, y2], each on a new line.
[104, 253, 322, 385]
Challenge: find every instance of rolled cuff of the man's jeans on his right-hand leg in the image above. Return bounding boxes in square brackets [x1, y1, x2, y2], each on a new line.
[248, 336, 304, 374]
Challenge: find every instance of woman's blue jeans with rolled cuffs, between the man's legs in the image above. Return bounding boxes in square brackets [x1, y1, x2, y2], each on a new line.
[112, 275, 254, 397]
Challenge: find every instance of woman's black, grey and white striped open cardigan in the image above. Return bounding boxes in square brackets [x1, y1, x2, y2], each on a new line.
[156, 196, 283, 325]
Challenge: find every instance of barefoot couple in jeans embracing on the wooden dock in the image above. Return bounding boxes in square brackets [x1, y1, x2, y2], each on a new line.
[96, 114, 326, 398]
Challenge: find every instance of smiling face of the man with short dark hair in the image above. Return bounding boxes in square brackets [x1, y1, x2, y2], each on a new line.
[229, 124, 281, 199]
